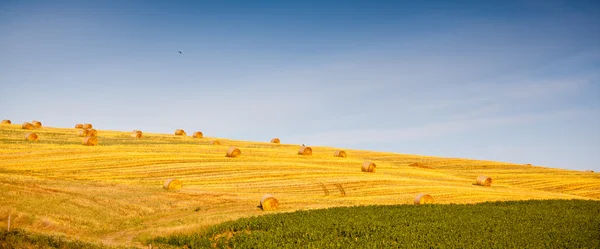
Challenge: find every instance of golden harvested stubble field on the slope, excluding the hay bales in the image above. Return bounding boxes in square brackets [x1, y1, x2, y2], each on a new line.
[0, 125, 600, 246]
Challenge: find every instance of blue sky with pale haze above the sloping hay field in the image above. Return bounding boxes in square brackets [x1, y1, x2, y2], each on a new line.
[0, 0, 600, 171]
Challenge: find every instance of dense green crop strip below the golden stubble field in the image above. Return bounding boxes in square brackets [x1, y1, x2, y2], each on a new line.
[148, 200, 600, 248]
